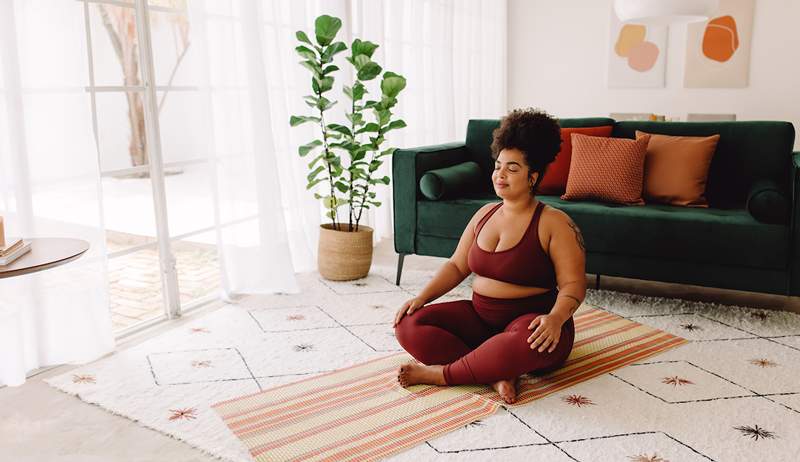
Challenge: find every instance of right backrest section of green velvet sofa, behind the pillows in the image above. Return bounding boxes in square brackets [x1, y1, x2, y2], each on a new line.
[611, 121, 795, 208]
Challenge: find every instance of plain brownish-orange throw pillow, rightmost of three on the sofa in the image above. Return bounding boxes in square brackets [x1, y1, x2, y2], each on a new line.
[636, 130, 719, 207]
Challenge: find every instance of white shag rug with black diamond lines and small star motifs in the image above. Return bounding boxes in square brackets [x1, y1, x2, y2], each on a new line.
[47, 266, 800, 462]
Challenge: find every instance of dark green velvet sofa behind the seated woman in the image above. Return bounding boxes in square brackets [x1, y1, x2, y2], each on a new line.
[392, 118, 800, 295]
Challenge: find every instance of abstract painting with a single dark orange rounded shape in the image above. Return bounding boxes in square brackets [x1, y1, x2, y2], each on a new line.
[683, 0, 755, 88]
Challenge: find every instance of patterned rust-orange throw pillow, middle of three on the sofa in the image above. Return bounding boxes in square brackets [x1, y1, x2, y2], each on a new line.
[561, 133, 650, 205]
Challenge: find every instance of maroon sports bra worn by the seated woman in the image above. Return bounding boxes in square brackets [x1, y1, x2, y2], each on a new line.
[467, 202, 556, 288]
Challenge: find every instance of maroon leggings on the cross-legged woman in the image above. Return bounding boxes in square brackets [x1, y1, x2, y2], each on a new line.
[395, 289, 575, 385]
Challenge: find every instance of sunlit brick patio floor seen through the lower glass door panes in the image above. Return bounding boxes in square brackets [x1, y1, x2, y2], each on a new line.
[106, 231, 220, 331]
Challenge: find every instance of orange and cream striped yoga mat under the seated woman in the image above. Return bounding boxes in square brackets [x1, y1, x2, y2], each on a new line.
[213, 305, 687, 461]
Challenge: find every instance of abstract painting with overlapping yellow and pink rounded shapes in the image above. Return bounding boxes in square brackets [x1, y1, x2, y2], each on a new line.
[608, 8, 667, 88]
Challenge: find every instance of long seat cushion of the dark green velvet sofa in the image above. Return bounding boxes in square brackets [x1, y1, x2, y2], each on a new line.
[417, 194, 789, 269]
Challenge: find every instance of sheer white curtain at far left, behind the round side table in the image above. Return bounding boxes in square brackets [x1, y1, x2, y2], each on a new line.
[0, 0, 114, 385]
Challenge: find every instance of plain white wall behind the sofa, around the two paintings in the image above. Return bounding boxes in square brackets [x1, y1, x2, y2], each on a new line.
[507, 0, 800, 150]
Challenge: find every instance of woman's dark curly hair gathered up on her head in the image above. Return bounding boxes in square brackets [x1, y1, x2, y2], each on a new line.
[492, 108, 561, 194]
